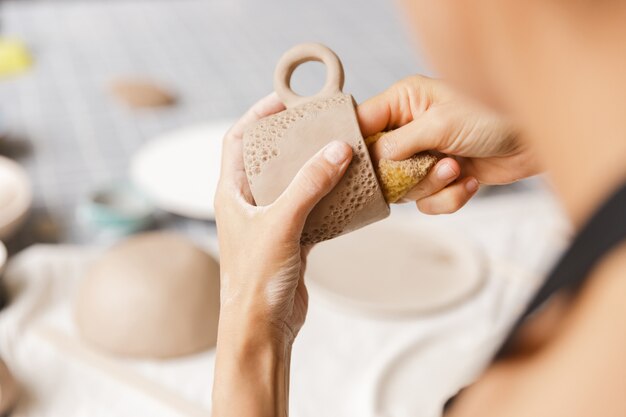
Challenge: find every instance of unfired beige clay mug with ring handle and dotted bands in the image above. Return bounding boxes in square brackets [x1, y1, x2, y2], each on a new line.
[243, 43, 389, 245]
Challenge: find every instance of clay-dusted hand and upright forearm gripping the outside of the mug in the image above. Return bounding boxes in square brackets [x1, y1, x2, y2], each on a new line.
[213, 94, 352, 417]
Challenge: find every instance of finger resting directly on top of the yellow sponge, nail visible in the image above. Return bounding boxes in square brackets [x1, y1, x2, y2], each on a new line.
[370, 108, 458, 161]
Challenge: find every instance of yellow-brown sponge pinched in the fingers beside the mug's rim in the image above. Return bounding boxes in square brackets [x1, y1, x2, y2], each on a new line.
[365, 132, 439, 203]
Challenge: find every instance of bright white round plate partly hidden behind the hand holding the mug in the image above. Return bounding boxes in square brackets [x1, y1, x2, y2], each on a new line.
[130, 121, 232, 220]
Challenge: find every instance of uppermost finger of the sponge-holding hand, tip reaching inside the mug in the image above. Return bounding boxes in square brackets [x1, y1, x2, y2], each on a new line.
[357, 75, 436, 137]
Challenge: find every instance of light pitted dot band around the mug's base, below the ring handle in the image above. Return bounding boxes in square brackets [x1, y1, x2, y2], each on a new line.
[244, 94, 350, 182]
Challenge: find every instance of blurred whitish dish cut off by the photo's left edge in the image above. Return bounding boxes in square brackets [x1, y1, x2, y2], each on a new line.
[0, 156, 32, 240]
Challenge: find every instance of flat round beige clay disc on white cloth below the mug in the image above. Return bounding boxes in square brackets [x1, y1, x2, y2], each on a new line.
[307, 216, 486, 315]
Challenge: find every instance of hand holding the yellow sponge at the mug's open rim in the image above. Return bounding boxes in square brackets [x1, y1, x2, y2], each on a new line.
[357, 76, 540, 214]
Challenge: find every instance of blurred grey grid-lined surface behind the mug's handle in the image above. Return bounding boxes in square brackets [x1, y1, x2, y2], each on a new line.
[0, 0, 426, 250]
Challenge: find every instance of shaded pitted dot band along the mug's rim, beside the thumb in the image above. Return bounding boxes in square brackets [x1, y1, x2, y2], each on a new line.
[300, 141, 378, 245]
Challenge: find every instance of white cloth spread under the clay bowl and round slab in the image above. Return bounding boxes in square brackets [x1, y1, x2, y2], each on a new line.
[0, 186, 568, 417]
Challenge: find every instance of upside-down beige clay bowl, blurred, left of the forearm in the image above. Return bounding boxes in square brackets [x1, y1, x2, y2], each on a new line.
[74, 232, 219, 358]
